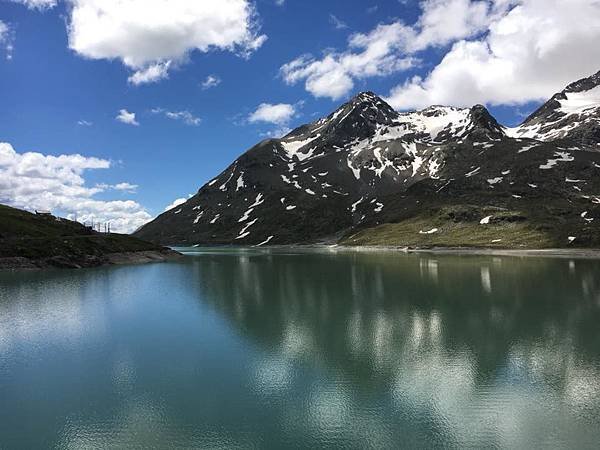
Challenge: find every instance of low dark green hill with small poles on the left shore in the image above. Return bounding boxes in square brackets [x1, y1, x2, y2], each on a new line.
[0, 205, 177, 268]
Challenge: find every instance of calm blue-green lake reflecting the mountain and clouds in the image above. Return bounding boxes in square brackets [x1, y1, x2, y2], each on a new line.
[0, 249, 600, 449]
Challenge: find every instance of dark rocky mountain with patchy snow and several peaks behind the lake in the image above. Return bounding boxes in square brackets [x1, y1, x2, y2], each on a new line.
[136, 73, 600, 248]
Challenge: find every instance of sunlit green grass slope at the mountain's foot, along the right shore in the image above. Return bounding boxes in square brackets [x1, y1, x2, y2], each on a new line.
[341, 202, 600, 249]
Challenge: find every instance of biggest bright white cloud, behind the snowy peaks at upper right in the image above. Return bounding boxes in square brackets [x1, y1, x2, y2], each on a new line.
[388, 0, 600, 109]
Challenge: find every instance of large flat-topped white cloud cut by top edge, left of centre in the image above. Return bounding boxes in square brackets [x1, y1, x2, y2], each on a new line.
[68, 0, 266, 85]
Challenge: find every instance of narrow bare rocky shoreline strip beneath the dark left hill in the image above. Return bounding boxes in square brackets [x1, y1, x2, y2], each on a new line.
[0, 249, 183, 271]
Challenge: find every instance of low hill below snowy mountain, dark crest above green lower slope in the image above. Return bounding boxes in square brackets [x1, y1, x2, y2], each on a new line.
[340, 182, 600, 250]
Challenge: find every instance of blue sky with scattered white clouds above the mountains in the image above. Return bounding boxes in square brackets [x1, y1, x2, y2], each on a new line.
[0, 0, 600, 232]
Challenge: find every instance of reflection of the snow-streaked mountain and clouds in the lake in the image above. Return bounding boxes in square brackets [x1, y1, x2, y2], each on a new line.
[185, 251, 600, 447]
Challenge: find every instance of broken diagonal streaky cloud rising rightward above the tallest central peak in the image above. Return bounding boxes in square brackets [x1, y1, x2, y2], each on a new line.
[280, 0, 512, 100]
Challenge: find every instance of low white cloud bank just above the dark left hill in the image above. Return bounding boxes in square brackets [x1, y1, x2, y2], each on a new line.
[0, 143, 151, 233]
